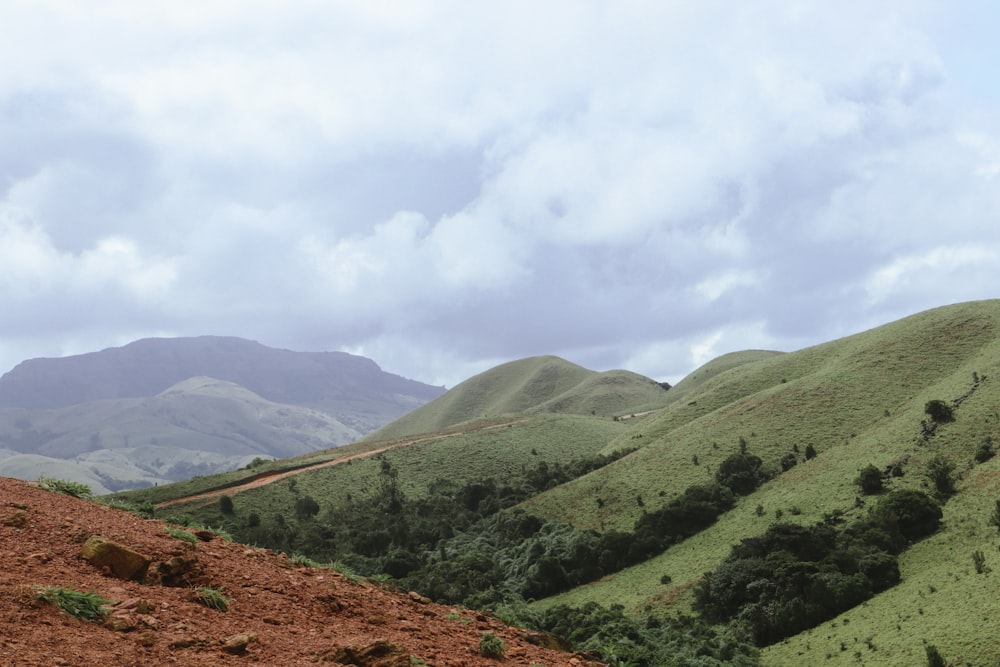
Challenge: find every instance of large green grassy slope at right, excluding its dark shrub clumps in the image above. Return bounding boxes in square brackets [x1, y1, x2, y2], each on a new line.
[526, 301, 1000, 665]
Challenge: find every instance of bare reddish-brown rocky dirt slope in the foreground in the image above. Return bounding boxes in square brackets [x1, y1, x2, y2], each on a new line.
[0, 478, 602, 667]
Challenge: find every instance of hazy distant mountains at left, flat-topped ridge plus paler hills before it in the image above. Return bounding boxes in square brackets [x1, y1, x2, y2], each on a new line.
[0, 336, 444, 493]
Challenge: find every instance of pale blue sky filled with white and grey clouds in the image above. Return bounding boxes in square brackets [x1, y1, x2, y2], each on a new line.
[0, 0, 1000, 387]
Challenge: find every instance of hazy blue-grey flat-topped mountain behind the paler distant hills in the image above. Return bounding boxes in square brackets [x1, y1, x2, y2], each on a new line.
[0, 336, 444, 433]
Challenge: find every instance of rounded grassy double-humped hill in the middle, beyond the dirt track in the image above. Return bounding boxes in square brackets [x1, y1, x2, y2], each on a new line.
[366, 356, 669, 440]
